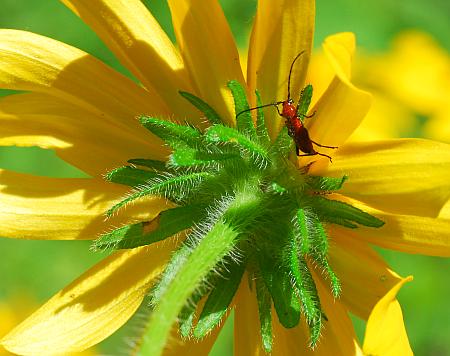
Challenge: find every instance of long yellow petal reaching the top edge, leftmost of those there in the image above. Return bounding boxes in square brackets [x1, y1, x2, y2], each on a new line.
[62, 0, 194, 118]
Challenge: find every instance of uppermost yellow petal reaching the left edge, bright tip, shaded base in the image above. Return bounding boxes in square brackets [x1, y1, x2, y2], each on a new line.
[0, 30, 168, 138]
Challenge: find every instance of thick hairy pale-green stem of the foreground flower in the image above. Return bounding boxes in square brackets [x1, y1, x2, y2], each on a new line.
[140, 219, 238, 355]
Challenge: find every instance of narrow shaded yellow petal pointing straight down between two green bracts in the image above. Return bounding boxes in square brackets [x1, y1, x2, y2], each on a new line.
[234, 277, 266, 356]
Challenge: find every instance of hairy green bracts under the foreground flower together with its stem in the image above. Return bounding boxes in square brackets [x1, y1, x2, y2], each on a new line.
[103, 81, 383, 355]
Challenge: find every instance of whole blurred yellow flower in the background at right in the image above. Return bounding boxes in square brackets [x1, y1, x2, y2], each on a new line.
[351, 30, 450, 142]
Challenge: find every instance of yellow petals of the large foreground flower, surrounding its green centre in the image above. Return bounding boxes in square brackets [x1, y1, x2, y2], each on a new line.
[0, 0, 450, 355]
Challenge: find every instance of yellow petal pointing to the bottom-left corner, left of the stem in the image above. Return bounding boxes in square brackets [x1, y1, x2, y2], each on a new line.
[1, 242, 173, 355]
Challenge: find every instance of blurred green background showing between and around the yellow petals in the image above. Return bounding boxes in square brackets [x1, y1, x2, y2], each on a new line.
[0, 0, 450, 355]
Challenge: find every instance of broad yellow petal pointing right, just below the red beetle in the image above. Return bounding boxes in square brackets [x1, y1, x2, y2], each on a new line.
[325, 139, 450, 216]
